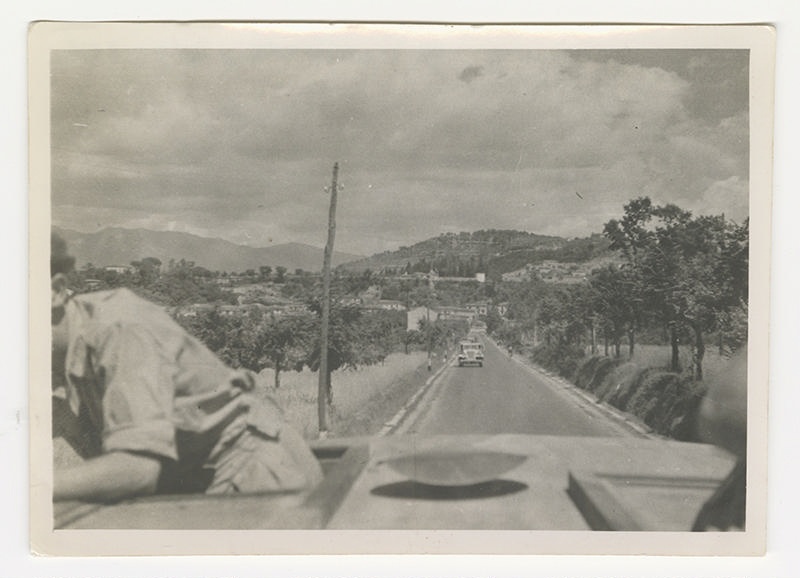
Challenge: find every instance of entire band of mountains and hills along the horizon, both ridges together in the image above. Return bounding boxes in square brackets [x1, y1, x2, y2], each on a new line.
[53, 227, 611, 279]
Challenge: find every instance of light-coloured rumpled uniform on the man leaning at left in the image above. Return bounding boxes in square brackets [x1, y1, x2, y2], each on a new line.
[53, 289, 322, 493]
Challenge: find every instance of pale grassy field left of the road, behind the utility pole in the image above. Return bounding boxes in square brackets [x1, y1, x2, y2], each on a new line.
[253, 352, 436, 439]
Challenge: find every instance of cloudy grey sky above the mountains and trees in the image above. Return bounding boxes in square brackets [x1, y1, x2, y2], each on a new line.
[51, 49, 749, 255]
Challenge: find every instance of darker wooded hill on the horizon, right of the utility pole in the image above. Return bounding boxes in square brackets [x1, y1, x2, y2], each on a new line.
[340, 229, 609, 279]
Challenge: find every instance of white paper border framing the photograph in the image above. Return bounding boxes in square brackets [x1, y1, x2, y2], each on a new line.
[29, 22, 775, 556]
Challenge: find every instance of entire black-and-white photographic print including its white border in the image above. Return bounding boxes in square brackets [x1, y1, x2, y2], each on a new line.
[29, 23, 774, 555]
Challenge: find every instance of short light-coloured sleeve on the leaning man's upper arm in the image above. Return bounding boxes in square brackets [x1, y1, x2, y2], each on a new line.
[97, 325, 177, 460]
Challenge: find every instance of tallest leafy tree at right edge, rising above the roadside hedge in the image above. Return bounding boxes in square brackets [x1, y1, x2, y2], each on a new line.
[604, 198, 748, 380]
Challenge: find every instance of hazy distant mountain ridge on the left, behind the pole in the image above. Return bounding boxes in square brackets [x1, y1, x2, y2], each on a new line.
[53, 227, 363, 272]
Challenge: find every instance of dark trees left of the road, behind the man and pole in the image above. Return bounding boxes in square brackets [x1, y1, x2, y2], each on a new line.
[70, 257, 462, 402]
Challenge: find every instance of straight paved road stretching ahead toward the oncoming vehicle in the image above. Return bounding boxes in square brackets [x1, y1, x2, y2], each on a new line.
[398, 340, 631, 437]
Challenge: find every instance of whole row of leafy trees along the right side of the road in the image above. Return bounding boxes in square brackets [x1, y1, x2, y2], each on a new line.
[494, 197, 749, 380]
